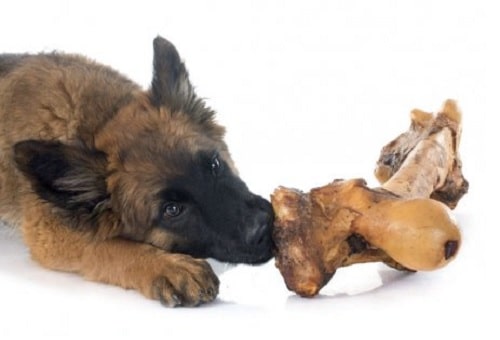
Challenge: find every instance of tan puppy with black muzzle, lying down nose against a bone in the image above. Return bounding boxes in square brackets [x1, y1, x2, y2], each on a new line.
[0, 36, 274, 306]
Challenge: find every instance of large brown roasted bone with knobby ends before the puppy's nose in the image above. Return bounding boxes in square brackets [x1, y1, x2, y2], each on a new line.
[271, 100, 468, 296]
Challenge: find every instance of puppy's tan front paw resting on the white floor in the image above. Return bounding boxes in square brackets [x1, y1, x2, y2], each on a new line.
[151, 254, 219, 307]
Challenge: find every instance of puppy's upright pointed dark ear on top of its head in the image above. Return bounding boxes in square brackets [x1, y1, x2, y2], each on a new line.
[151, 36, 196, 112]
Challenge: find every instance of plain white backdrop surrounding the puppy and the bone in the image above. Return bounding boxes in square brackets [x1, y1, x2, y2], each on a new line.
[0, 0, 500, 339]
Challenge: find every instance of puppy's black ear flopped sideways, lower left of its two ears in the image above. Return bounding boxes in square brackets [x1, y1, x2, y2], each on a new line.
[14, 140, 109, 214]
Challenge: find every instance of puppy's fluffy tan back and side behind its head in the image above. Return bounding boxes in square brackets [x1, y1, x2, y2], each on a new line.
[0, 53, 139, 224]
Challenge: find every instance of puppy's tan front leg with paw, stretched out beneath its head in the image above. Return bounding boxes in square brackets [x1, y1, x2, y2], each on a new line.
[23, 208, 219, 306]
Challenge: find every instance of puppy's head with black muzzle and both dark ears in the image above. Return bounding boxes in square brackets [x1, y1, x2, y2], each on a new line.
[14, 37, 273, 263]
